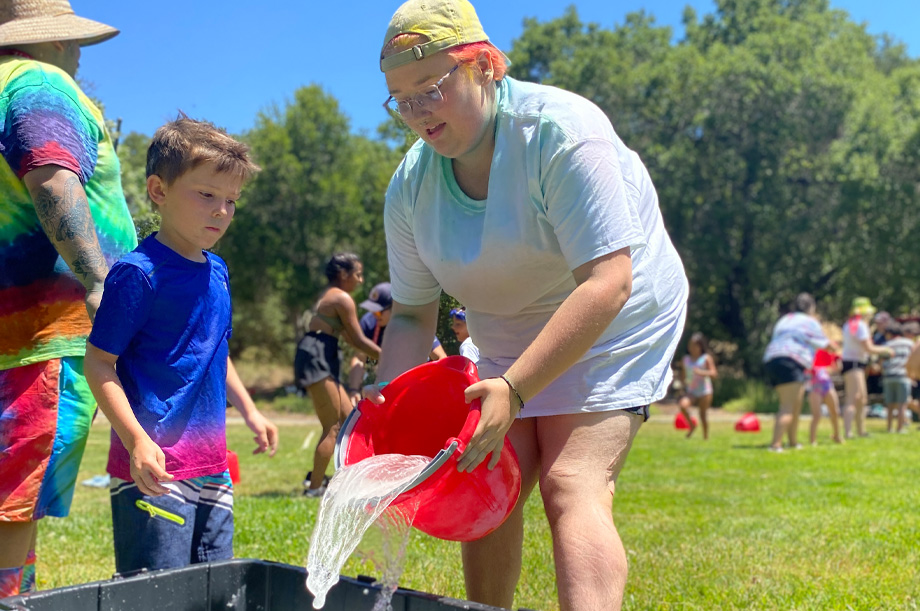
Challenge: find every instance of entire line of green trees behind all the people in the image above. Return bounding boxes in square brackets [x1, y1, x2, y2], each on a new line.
[113, 0, 920, 373]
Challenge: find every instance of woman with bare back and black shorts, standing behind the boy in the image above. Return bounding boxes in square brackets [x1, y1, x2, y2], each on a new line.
[294, 253, 380, 496]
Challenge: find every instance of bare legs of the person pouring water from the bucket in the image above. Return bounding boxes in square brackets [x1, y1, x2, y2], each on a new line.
[463, 412, 642, 611]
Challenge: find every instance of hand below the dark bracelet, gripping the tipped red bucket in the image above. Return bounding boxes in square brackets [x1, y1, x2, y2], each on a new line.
[457, 378, 521, 473]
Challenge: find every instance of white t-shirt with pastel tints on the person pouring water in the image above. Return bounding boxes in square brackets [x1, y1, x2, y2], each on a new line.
[384, 77, 688, 415]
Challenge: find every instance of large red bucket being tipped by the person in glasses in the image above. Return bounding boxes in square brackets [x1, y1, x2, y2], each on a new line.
[335, 356, 521, 541]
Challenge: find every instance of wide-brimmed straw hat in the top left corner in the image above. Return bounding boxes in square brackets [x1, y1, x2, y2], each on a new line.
[0, 0, 118, 47]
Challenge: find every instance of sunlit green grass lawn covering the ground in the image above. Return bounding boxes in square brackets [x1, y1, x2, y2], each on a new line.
[32, 416, 920, 611]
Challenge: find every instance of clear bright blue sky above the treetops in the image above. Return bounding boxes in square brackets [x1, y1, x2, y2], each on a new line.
[71, 0, 920, 134]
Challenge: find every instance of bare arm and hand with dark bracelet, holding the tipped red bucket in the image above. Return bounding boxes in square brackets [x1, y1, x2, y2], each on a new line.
[458, 247, 632, 471]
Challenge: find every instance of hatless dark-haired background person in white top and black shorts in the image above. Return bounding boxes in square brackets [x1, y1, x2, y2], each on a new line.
[763, 293, 830, 452]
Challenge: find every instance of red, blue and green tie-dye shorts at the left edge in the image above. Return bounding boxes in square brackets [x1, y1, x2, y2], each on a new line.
[0, 357, 96, 522]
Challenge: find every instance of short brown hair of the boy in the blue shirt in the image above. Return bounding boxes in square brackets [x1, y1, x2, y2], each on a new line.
[147, 114, 261, 184]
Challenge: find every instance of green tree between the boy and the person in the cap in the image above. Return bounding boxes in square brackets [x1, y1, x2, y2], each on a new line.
[218, 86, 398, 355]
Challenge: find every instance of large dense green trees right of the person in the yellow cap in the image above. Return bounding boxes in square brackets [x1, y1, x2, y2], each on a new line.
[510, 0, 920, 373]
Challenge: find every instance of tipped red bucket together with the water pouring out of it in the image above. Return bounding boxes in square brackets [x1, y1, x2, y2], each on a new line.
[307, 356, 521, 608]
